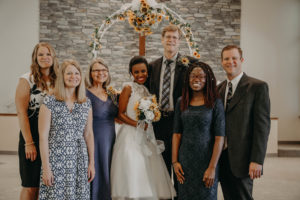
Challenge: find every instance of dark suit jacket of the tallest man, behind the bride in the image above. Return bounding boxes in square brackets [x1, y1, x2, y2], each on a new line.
[149, 53, 197, 107]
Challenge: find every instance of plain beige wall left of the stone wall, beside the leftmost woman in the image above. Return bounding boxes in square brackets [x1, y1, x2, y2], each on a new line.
[0, 0, 39, 113]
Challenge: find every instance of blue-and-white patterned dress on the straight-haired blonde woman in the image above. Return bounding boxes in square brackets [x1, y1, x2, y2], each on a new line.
[39, 96, 91, 200]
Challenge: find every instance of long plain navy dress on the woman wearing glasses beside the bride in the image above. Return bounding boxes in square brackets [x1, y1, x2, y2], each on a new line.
[86, 90, 118, 200]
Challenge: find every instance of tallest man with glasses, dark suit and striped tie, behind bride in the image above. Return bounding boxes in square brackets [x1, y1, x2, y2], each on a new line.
[149, 25, 196, 173]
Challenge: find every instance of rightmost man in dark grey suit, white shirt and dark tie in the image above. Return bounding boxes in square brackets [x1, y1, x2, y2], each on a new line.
[218, 45, 270, 200]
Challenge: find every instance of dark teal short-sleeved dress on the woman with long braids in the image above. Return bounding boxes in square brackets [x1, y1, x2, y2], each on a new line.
[174, 99, 225, 200]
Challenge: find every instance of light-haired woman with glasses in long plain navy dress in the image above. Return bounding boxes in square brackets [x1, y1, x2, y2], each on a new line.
[85, 59, 118, 200]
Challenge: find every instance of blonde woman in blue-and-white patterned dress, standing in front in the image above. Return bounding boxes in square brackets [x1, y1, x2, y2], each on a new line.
[39, 60, 95, 200]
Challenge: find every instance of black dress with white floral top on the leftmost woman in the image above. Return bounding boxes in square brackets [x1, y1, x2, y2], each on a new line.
[18, 72, 47, 187]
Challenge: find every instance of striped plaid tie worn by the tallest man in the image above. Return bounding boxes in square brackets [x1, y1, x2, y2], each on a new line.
[161, 60, 173, 111]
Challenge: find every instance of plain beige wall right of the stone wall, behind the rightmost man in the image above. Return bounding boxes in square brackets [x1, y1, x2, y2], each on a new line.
[241, 0, 300, 141]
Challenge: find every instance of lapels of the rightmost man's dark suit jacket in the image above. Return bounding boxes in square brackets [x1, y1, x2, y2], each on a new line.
[224, 73, 248, 112]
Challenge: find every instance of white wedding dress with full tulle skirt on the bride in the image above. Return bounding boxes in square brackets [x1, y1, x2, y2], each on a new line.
[111, 82, 176, 200]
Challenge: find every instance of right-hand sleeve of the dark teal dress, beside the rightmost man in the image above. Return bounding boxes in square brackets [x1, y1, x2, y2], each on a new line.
[213, 99, 225, 136]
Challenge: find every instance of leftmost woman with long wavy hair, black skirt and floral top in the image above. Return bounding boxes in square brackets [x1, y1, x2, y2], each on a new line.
[15, 42, 58, 200]
